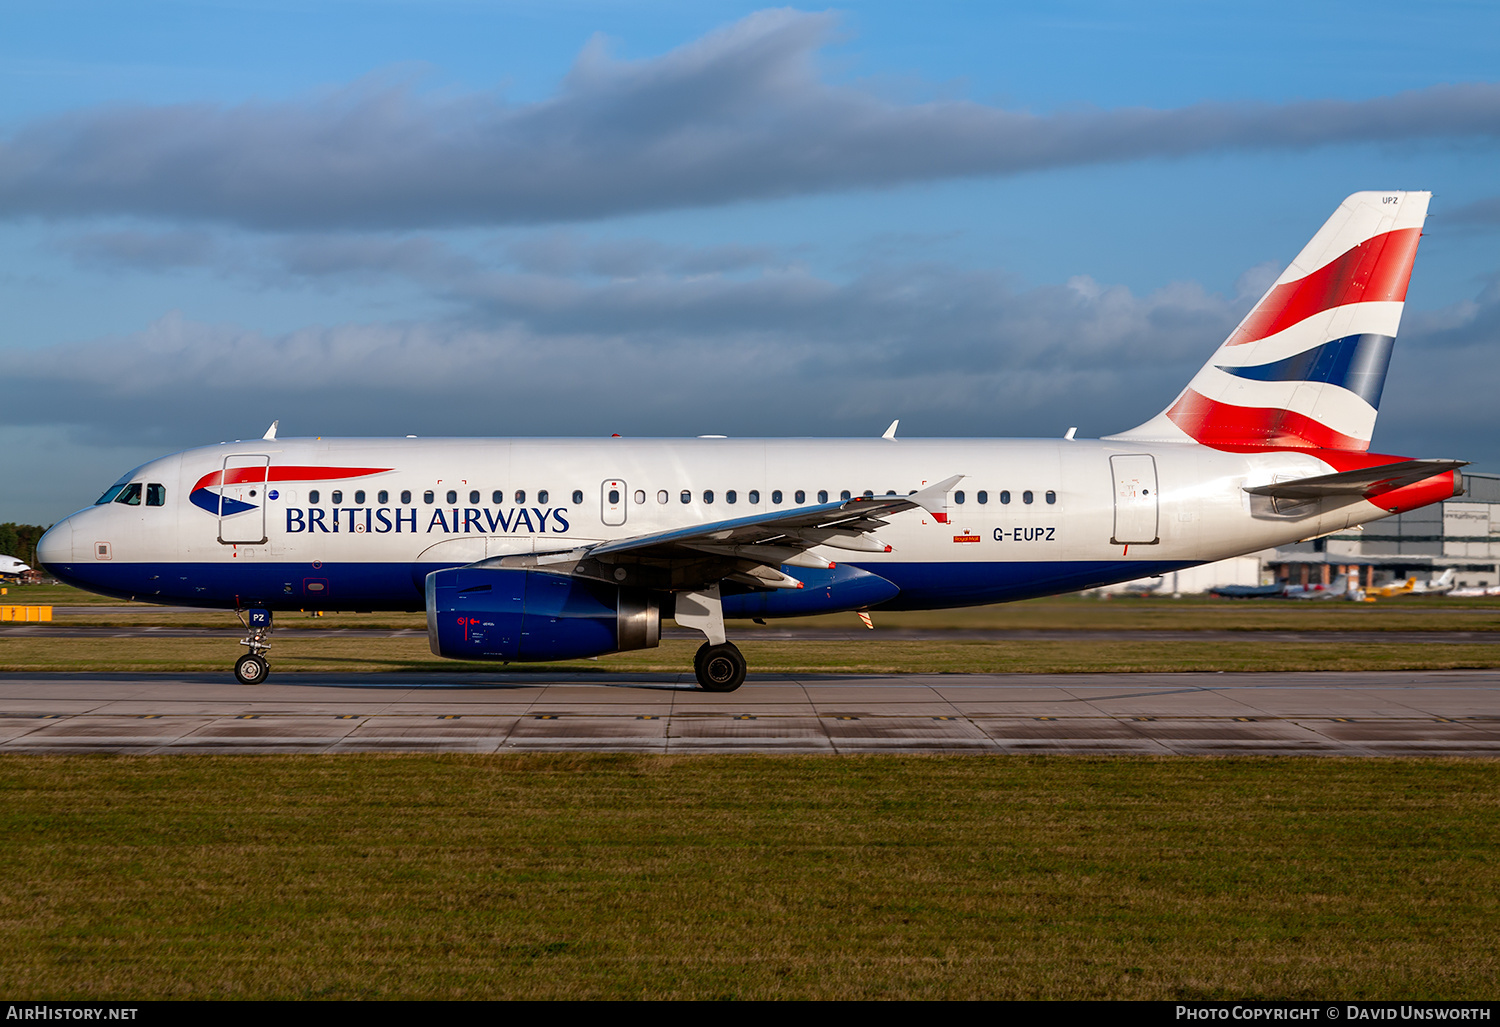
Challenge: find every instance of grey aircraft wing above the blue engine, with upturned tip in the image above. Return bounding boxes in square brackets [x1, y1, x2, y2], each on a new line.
[477, 474, 965, 589]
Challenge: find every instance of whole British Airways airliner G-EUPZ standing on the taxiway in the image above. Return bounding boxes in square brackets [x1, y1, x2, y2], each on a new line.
[39, 192, 1464, 691]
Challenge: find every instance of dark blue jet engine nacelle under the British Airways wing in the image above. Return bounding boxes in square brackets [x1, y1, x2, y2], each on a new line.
[428, 567, 662, 663]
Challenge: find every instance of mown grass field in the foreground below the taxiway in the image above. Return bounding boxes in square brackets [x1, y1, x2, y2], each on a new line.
[0, 754, 1500, 999]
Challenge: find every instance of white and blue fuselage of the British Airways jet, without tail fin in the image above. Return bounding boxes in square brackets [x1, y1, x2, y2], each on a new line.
[39, 438, 1389, 616]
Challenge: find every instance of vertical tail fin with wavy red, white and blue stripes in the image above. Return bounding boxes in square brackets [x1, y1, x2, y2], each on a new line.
[1107, 192, 1433, 453]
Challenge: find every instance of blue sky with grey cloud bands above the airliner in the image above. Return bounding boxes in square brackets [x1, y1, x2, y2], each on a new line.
[0, 0, 1500, 523]
